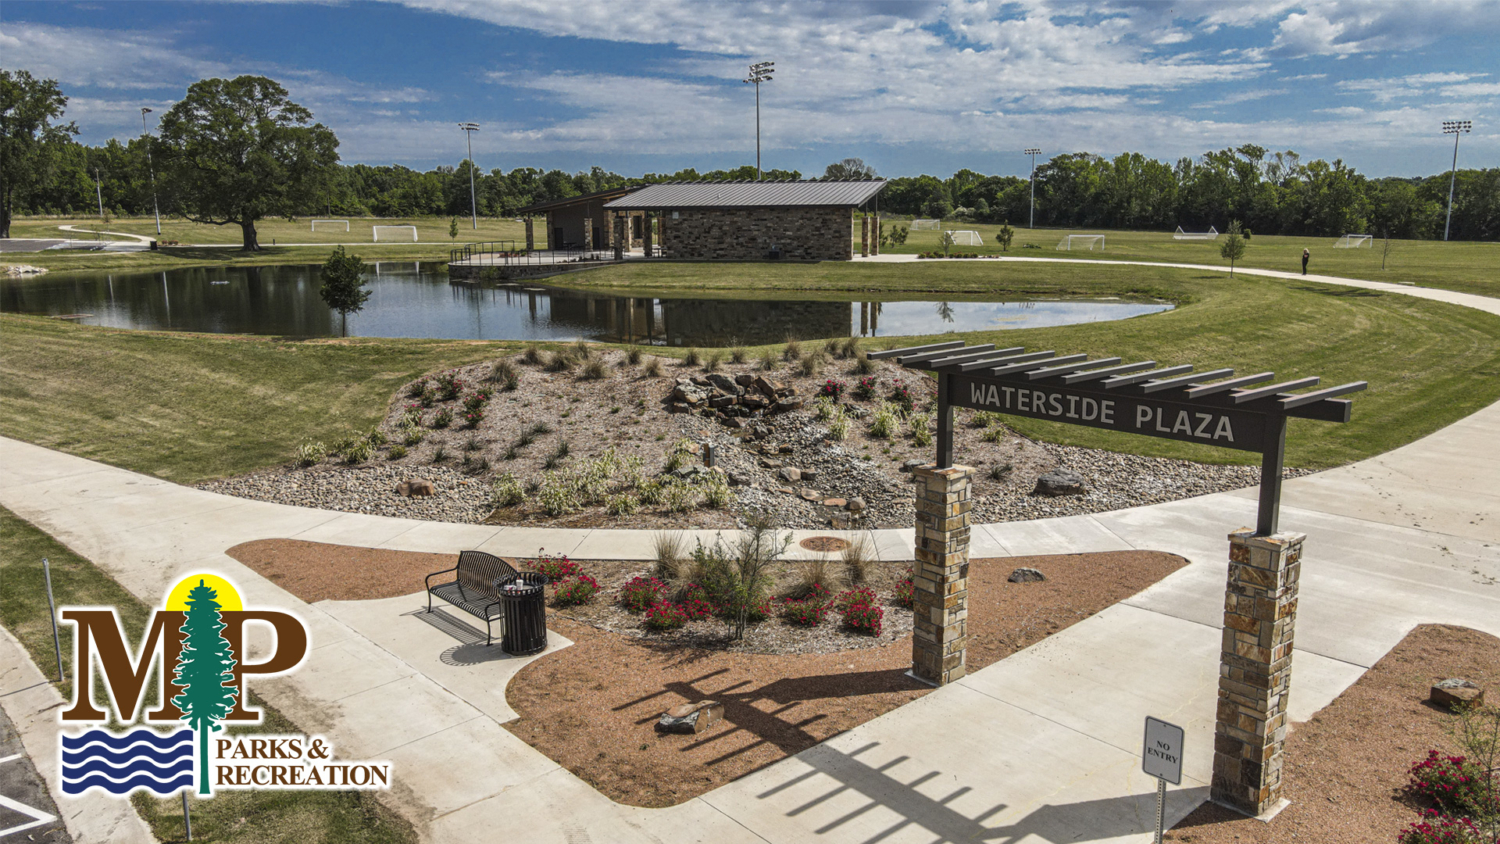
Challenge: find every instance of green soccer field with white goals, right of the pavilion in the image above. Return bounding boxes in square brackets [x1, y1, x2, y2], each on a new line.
[876, 220, 1500, 295]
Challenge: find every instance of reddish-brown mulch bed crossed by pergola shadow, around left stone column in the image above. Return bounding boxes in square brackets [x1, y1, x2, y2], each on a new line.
[506, 552, 1184, 807]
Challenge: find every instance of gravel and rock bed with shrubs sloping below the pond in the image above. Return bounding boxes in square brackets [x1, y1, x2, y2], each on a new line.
[200, 352, 1308, 529]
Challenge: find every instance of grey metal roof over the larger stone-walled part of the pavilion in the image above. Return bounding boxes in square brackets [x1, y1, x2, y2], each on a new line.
[605, 178, 885, 211]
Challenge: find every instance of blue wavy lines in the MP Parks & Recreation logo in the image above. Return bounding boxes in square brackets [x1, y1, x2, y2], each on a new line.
[62, 727, 194, 796]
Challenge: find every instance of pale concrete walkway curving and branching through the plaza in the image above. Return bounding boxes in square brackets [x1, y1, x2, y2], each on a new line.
[0, 260, 1500, 844]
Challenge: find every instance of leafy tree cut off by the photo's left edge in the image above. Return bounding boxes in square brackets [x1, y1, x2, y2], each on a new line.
[0, 69, 78, 237]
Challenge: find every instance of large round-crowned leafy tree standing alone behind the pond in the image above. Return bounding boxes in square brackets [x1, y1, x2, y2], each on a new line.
[159, 76, 339, 252]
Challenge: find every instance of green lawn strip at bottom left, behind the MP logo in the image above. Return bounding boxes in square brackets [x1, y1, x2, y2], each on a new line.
[0, 508, 417, 844]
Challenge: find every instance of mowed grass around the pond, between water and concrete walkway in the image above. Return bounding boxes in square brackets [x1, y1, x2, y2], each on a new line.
[0, 261, 1500, 483]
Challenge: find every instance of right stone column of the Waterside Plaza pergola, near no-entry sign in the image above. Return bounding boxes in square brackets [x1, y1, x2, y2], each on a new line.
[1209, 528, 1307, 816]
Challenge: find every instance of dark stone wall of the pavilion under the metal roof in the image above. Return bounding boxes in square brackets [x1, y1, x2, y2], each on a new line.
[662, 208, 854, 261]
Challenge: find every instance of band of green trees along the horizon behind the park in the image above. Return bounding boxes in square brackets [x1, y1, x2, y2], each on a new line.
[0, 70, 1500, 249]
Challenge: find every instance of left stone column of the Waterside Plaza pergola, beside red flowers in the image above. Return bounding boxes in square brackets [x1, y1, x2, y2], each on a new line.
[912, 465, 974, 685]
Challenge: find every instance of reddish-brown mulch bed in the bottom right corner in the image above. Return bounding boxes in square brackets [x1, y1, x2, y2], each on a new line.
[1166, 625, 1500, 844]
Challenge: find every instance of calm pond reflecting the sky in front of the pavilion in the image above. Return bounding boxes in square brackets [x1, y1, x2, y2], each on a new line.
[0, 261, 1172, 346]
